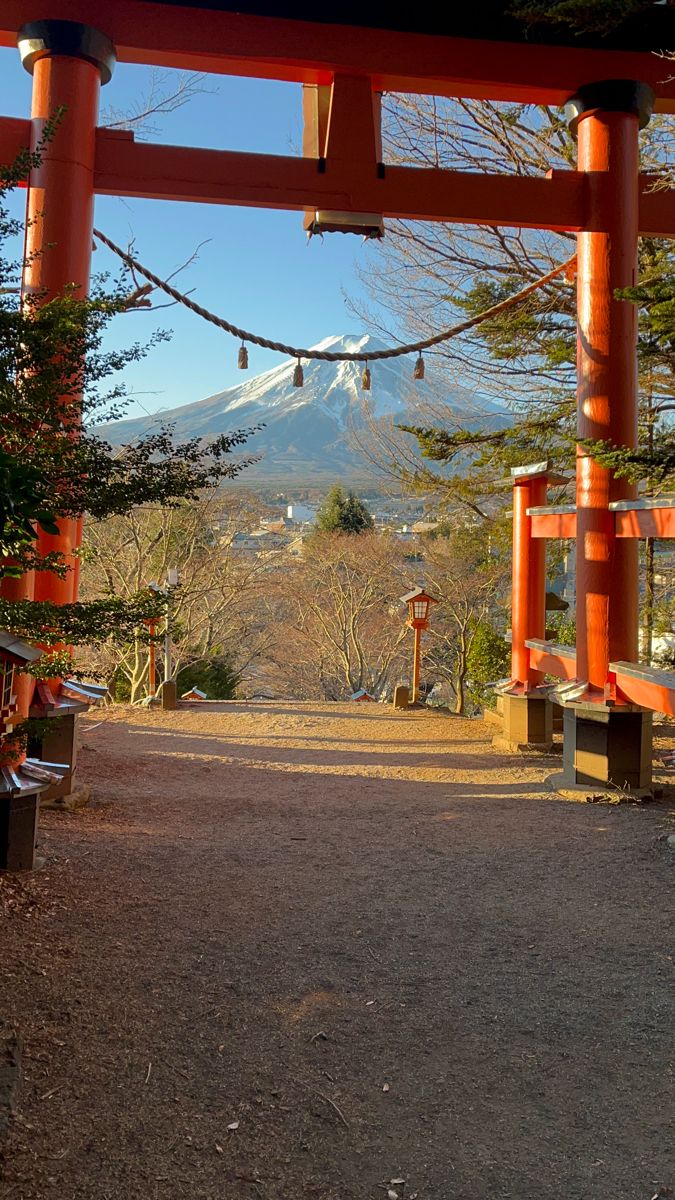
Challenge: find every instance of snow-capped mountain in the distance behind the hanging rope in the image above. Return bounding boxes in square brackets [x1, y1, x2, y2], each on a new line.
[100, 335, 496, 484]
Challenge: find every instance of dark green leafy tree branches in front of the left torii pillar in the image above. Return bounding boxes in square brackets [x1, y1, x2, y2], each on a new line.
[0, 145, 251, 662]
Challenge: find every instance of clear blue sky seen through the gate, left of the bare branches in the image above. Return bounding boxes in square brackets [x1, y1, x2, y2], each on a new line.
[0, 49, 384, 415]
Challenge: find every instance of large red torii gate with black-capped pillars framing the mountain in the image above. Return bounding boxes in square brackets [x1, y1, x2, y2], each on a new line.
[0, 0, 675, 787]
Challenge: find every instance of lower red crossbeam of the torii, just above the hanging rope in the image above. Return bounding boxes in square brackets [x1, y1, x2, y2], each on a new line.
[0, 116, 675, 235]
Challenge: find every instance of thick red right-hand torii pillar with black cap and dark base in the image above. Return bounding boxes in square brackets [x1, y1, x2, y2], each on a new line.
[565, 80, 653, 788]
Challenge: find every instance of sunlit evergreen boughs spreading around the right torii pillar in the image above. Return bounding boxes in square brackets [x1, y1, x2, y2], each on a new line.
[400, 239, 675, 512]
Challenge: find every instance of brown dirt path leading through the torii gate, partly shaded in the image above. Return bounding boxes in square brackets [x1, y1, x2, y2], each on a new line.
[0, 703, 674, 1200]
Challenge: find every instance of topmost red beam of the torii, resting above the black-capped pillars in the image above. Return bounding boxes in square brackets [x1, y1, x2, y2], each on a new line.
[0, 0, 675, 112]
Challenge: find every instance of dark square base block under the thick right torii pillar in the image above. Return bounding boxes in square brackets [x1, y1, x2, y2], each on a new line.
[560, 704, 652, 792]
